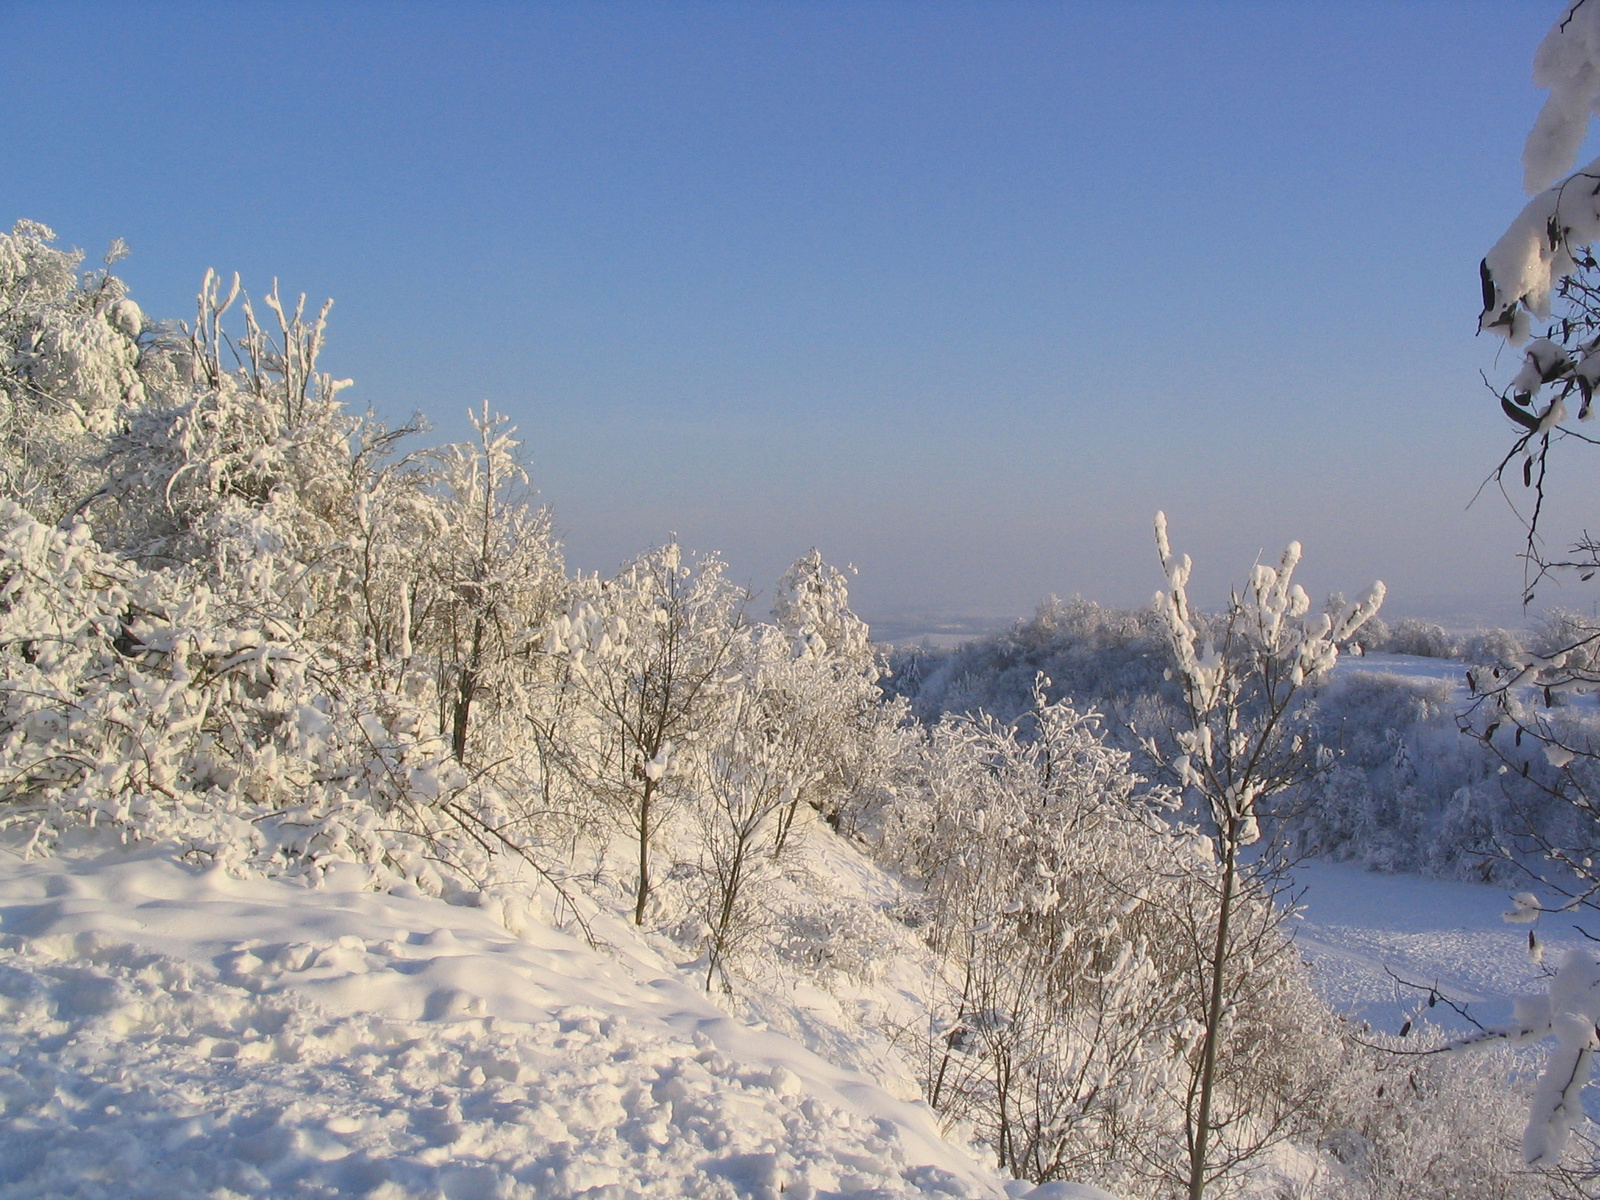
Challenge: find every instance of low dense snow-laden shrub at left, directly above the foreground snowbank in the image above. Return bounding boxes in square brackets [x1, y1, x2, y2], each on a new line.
[0, 501, 492, 874]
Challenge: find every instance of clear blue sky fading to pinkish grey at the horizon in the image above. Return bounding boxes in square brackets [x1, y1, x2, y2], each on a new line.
[0, 0, 1574, 624]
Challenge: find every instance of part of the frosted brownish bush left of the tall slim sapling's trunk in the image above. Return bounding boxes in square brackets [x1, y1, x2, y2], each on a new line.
[882, 682, 1182, 1182]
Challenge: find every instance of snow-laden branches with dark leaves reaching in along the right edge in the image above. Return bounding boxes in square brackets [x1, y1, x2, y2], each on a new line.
[1462, 0, 1600, 1165]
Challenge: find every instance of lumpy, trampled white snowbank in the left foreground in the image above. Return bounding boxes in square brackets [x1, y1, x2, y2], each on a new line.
[0, 850, 1004, 1200]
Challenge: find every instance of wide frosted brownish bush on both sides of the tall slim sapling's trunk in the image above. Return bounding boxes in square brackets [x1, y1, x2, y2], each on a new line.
[882, 680, 1338, 1195]
